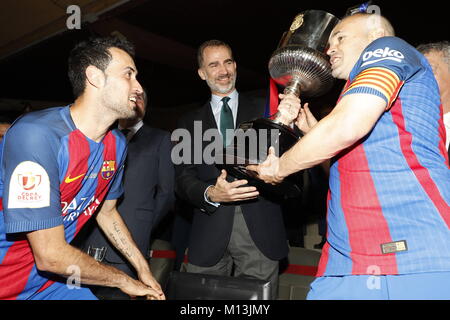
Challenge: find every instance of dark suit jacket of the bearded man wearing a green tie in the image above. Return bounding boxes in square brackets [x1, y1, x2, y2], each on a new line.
[175, 93, 288, 267]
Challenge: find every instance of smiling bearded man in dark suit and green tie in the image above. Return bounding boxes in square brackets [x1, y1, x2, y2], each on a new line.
[176, 40, 300, 298]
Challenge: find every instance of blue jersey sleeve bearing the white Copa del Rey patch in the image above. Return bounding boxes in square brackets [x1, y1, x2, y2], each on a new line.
[1, 122, 63, 233]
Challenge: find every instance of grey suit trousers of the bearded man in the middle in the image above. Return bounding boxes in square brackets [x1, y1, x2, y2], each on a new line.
[186, 206, 279, 300]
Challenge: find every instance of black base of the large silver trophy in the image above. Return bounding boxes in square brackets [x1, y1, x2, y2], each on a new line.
[216, 118, 303, 197]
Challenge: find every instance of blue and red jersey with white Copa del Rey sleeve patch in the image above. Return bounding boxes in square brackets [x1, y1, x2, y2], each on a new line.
[0, 106, 126, 299]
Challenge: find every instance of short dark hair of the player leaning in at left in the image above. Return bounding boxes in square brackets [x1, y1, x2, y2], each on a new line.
[68, 37, 134, 98]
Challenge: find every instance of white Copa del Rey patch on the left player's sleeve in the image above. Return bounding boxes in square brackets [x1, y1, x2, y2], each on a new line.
[8, 161, 50, 209]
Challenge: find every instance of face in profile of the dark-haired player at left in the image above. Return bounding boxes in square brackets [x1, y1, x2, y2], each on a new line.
[101, 48, 143, 119]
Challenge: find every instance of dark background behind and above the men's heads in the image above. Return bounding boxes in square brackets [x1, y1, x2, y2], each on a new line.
[0, 0, 449, 129]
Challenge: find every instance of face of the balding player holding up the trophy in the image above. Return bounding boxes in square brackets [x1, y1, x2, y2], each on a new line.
[327, 16, 374, 80]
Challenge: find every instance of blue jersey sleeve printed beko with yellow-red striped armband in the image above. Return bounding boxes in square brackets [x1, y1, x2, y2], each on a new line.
[342, 37, 422, 110]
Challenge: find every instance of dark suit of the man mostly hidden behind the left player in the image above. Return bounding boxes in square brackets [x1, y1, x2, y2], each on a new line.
[80, 124, 175, 274]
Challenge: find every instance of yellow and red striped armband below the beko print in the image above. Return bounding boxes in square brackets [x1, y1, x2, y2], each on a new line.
[342, 67, 403, 110]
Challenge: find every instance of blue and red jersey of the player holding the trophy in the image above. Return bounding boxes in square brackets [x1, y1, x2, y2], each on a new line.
[318, 37, 450, 276]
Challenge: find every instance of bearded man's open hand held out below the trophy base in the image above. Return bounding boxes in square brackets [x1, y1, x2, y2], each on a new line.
[207, 170, 259, 202]
